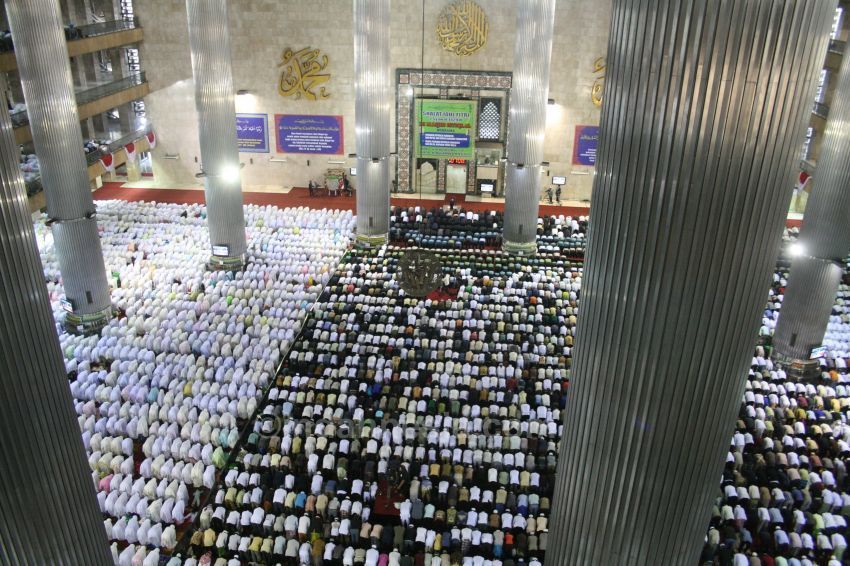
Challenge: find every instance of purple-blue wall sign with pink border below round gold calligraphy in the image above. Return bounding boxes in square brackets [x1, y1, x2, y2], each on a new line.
[274, 114, 344, 155]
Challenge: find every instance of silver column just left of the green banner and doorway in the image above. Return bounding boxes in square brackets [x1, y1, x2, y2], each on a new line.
[354, 0, 392, 246]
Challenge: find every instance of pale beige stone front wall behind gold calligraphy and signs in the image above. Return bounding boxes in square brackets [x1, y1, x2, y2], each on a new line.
[137, 0, 611, 202]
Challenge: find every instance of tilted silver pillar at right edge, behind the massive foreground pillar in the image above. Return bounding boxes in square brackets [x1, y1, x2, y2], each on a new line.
[773, 33, 850, 359]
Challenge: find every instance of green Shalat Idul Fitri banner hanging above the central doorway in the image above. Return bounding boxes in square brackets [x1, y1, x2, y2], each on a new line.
[416, 100, 476, 159]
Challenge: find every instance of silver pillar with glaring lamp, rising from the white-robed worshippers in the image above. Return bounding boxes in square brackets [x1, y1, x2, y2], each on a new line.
[186, 0, 247, 268]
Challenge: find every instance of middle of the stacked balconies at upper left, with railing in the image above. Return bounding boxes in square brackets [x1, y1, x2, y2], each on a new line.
[11, 71, 150, 145]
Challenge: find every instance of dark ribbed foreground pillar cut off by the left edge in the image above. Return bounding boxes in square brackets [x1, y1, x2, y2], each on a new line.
[0, 97, 112, 564]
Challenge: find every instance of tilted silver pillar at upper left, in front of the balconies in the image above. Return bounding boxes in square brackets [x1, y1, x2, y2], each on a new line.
[6, 0, 112, 327]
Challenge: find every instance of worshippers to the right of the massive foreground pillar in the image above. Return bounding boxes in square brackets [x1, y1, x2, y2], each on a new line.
[701, 252, 850, 566]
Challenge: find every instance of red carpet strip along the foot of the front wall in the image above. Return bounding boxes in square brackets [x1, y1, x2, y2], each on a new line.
[94, 183, 588, 216]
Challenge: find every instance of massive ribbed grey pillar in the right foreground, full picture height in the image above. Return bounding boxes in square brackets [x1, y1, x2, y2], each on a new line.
[546, 0, 835, 565]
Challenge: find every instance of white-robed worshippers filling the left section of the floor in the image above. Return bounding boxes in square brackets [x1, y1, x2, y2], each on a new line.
[35, 201, 353, 566]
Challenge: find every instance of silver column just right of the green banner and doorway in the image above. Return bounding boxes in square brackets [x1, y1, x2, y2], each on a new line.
[502, 0, 555, 254]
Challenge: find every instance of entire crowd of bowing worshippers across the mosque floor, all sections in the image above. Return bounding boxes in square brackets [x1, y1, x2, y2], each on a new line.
[36, 195, 850, 566]
